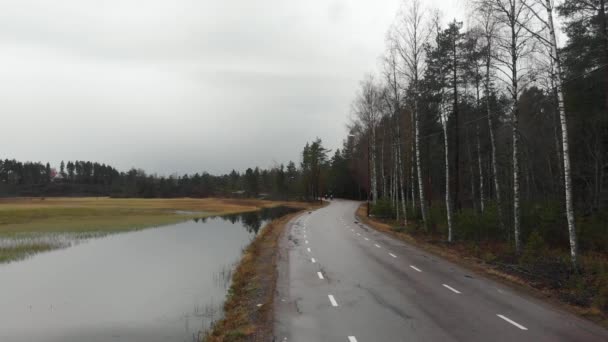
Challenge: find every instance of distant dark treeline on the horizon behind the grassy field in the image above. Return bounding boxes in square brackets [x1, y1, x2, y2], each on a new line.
[0, 159, 308, 199]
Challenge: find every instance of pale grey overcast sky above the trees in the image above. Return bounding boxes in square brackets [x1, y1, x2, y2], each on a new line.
[0, 0, 464, 174]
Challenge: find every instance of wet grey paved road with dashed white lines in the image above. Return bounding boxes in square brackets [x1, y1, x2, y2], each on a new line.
[275, 200, 608, 342]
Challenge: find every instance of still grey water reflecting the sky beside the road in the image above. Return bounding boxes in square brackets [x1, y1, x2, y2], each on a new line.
[0, 208, 293, 342]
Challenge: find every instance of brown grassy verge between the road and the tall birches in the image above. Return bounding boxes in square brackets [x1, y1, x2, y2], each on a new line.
[357, 206, 608, 327]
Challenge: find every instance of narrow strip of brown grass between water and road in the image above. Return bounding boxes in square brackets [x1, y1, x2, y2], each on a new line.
[204, 204, 318, 342]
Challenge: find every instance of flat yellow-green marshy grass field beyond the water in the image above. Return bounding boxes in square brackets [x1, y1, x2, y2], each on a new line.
[0, 197, 305, 263]
